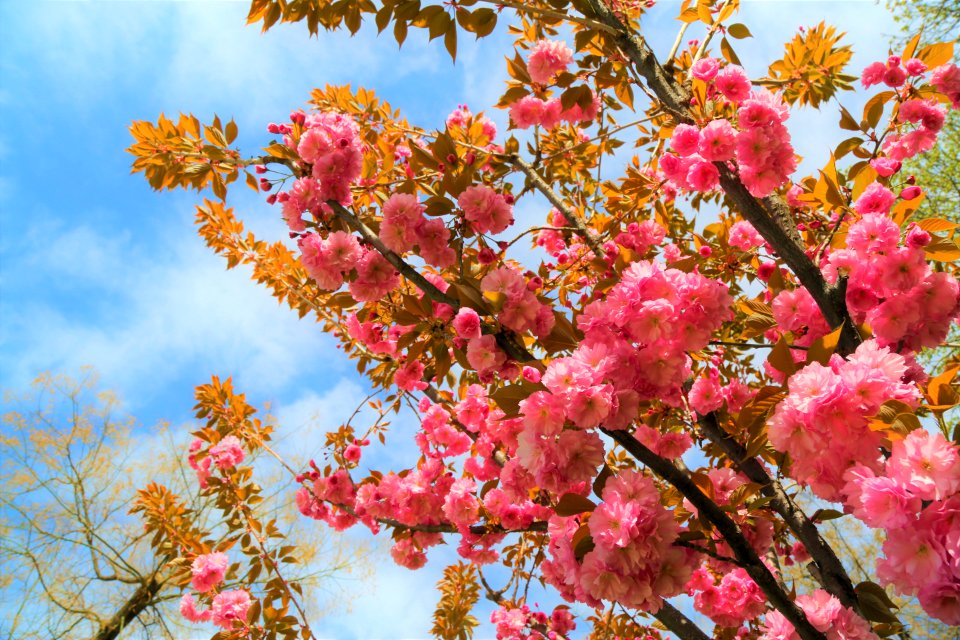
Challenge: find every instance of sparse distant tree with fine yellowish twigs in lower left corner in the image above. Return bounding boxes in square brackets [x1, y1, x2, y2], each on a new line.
[0, 371, 364, 640]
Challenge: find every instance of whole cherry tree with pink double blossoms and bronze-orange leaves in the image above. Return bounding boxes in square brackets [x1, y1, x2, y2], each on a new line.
[129, 0, 960, 640]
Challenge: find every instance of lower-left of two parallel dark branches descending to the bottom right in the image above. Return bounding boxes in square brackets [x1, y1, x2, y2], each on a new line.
[603, 429, 826, 640]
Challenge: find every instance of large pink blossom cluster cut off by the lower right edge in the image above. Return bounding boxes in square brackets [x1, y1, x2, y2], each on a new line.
[843, 429, 960, 625]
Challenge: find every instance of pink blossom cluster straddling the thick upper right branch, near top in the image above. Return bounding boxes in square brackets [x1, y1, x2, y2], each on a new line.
[660, 80, 797, 197]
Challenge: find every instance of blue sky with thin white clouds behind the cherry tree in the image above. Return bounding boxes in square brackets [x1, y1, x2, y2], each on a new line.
[0, 0, 893, 638]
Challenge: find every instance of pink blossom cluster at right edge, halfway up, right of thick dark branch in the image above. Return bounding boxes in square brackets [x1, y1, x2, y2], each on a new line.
[823, 209, 960, 351]
